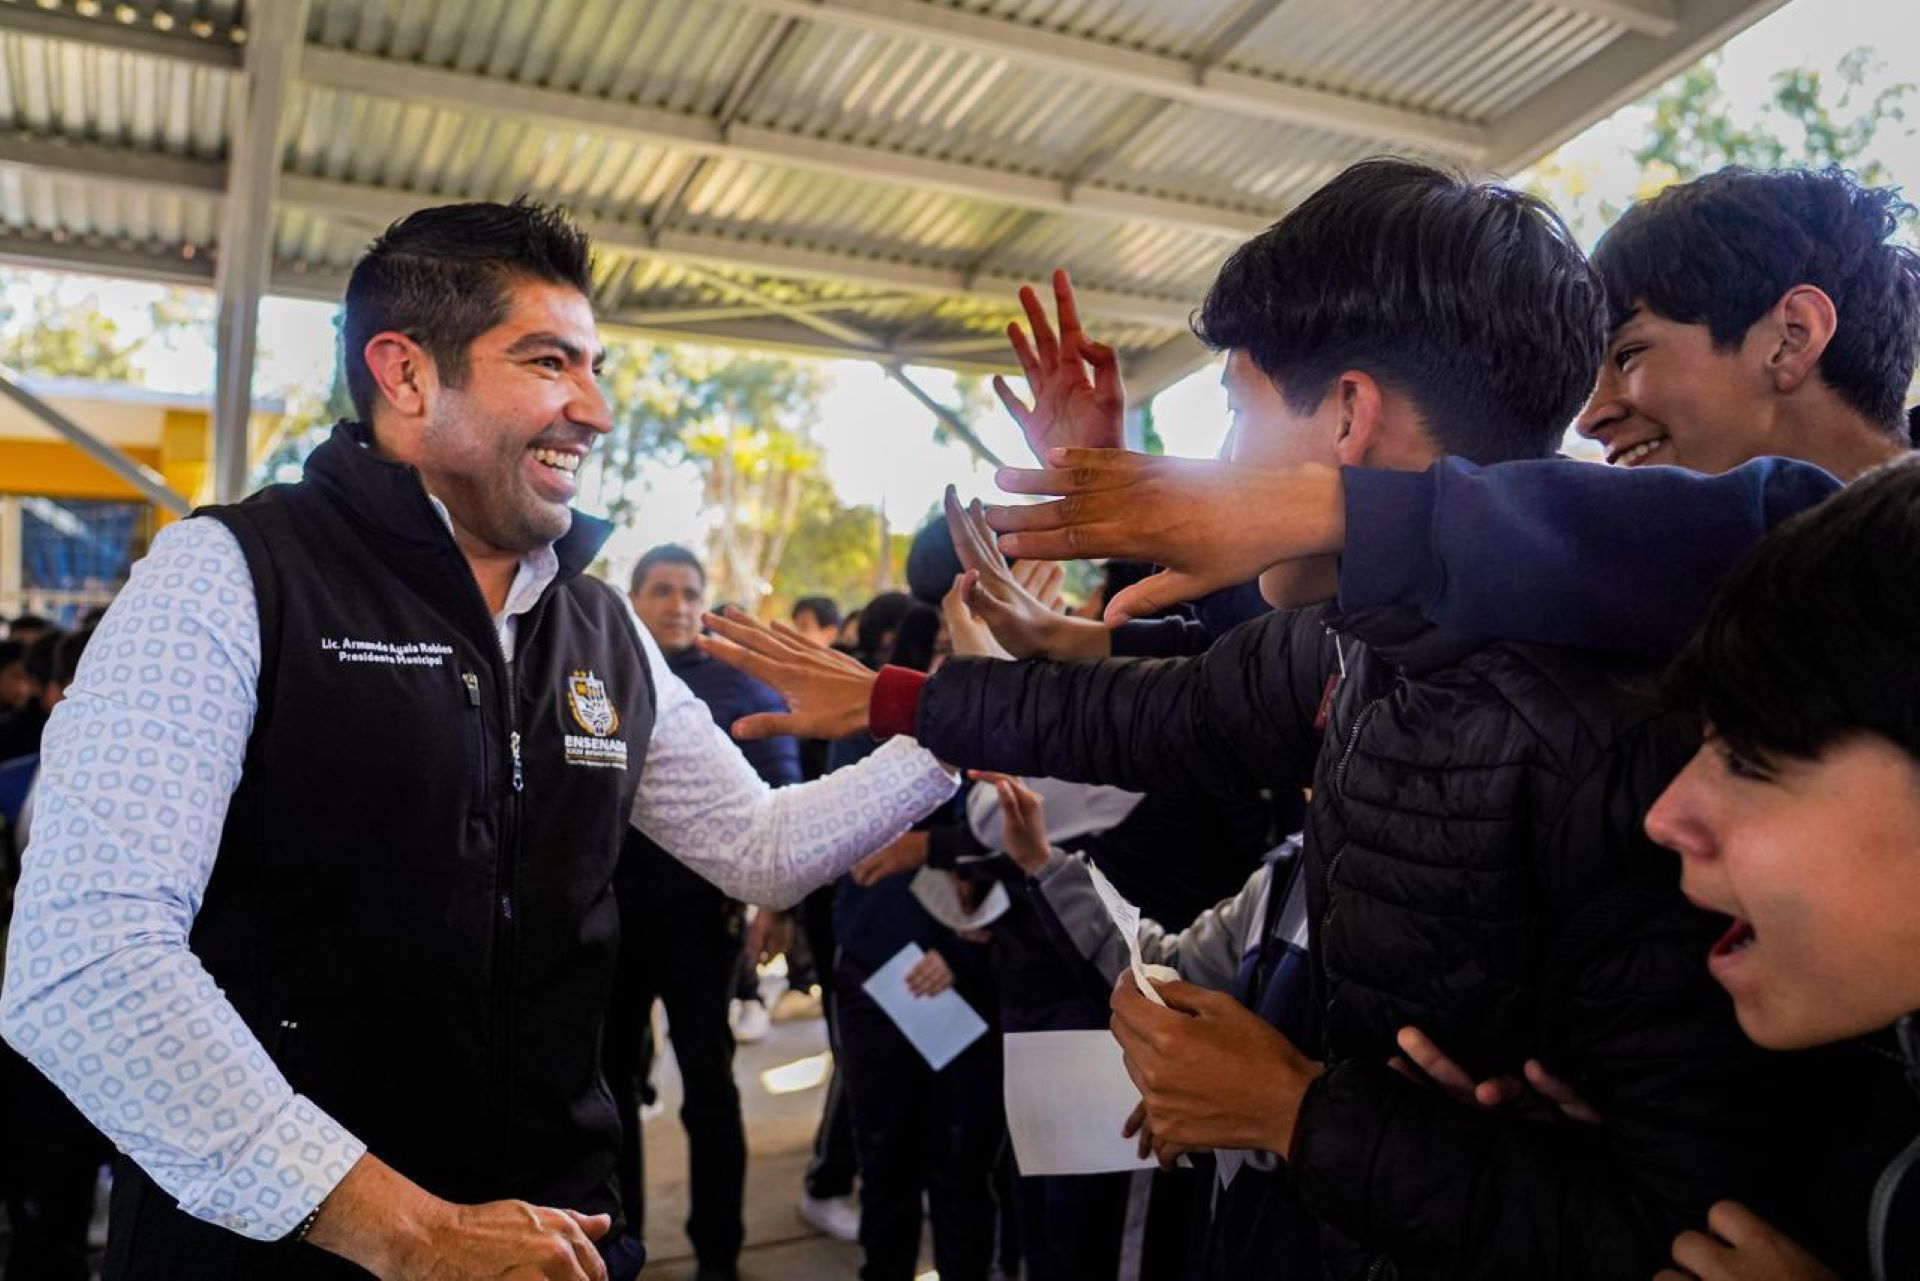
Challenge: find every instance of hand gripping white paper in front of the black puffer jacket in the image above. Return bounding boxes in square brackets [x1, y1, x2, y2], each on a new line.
[1112, 972, 1321, 1156]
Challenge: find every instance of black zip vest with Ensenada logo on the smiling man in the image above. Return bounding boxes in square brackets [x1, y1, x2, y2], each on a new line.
[108, 424, 655, 1277]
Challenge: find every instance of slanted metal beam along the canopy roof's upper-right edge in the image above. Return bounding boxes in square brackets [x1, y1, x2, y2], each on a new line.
[1486, 0, 1786, 173]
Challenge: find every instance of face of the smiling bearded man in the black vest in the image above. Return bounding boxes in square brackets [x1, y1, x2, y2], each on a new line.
[407, 280, 612, 553]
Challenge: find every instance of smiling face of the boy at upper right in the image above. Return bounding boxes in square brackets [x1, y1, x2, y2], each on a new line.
[1580, 307, 1778, 474]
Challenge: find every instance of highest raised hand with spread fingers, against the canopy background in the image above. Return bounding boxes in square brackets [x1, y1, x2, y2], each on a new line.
[993, 271, 1127, 459]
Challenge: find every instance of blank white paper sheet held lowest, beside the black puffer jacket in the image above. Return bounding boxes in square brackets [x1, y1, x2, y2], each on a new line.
[1002, 1031, 1154, 1177]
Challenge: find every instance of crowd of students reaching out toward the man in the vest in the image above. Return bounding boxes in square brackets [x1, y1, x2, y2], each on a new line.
[0, 159, 1920, 1281]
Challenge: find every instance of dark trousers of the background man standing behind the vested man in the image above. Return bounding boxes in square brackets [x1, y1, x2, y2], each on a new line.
[603, 885, 747, 1264]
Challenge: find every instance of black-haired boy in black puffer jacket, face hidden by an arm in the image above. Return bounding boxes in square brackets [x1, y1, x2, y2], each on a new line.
[710, 161, 1774, 1277]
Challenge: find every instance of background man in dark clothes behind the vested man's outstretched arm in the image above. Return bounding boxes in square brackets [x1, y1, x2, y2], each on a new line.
[605, 545, 801, 1281]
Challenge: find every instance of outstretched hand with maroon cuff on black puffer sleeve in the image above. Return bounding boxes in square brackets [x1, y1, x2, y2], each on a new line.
[693, 605, 876, 739]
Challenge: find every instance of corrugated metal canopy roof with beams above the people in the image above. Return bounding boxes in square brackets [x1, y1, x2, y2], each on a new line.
[0, 0, 1780, 495]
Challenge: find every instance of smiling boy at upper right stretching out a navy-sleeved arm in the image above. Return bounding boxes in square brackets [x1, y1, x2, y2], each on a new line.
[989, 169, 1920, 655]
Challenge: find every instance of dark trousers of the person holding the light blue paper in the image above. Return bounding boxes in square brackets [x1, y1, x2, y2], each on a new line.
[835, 962, 1006, 1281]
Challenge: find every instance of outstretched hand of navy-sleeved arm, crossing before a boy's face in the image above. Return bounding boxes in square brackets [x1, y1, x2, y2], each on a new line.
[987, 449, 1346, 624]
